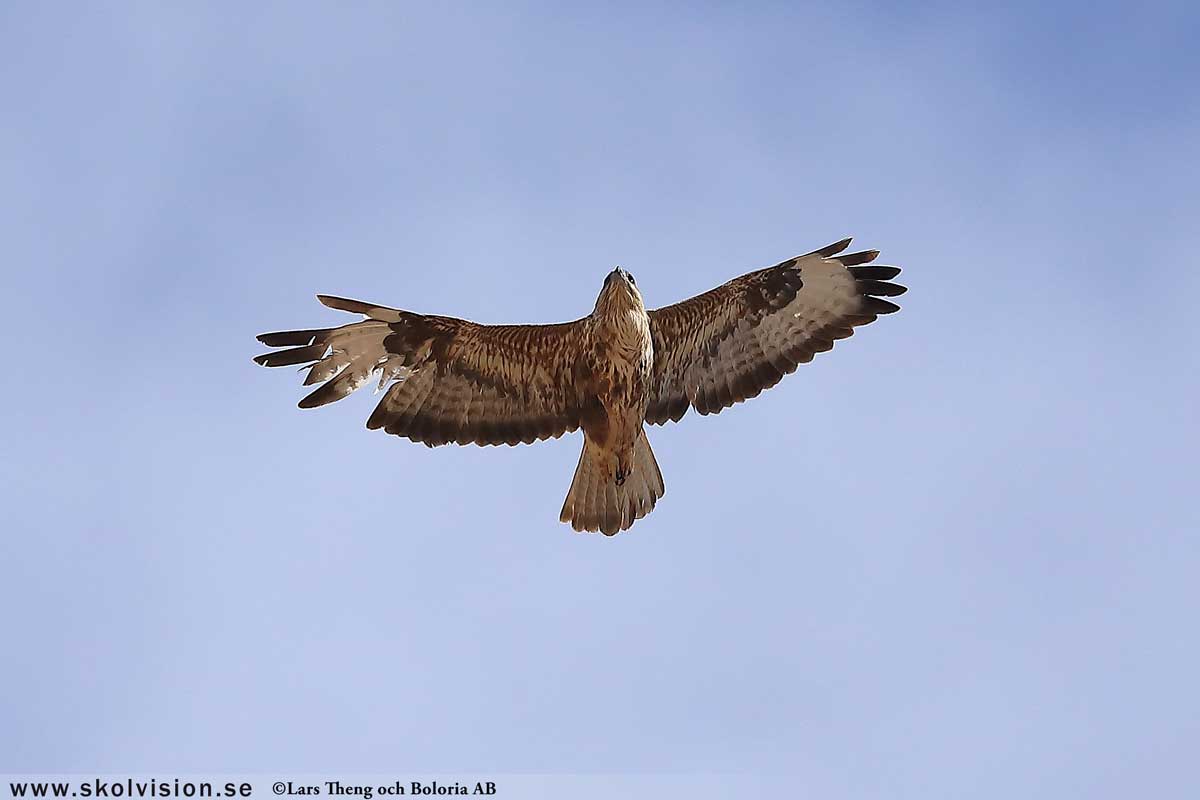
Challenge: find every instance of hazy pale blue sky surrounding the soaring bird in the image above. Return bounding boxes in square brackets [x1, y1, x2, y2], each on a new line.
[0, 2, 1200, 799]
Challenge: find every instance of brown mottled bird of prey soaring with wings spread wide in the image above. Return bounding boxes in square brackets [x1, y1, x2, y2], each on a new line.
[254, 239, 905, 535]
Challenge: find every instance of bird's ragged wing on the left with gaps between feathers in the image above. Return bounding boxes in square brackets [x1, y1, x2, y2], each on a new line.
[254, 295, 580, 447]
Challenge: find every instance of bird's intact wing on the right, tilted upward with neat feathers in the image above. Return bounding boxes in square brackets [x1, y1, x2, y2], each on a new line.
[646, 239, 905, 425]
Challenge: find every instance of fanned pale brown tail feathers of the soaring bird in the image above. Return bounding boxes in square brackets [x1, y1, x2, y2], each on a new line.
[558, 431, 666, 536]
